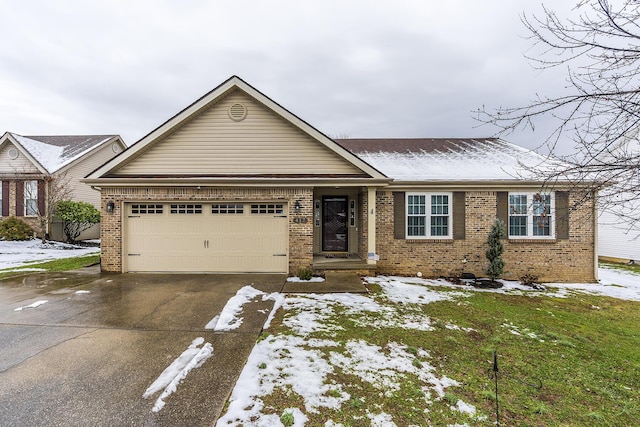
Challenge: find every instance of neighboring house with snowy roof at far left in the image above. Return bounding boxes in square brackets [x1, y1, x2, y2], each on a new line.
[0, 132, 126, 240]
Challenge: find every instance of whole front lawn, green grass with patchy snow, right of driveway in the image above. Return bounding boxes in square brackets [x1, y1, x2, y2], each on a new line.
[218, 275, 640, 427]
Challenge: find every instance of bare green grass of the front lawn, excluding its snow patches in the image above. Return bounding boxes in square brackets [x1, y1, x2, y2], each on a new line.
[255, 282, 640, 426]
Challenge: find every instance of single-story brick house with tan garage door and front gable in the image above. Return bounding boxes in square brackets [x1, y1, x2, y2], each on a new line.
[84, 76, 597, 281]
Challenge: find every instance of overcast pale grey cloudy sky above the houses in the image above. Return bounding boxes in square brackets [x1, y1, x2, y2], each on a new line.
[0, 0, 576, 154]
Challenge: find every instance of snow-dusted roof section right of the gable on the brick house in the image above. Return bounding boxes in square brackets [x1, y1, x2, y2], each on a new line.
[336, 138, 552, 181]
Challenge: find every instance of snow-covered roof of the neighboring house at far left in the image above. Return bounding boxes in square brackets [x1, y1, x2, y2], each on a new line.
[11, 133, 116, 173]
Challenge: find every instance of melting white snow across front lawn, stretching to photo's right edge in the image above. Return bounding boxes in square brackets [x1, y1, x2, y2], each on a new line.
[217, 268, 640, 427]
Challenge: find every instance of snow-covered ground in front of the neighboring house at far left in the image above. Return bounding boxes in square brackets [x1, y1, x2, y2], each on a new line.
[0, 239, 100, 270]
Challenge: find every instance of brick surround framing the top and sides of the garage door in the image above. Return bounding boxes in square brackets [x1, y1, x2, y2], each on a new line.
[100, 187, 313, 274]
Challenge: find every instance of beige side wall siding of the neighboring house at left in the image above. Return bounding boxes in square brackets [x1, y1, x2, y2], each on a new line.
[56, 143, 123, 209]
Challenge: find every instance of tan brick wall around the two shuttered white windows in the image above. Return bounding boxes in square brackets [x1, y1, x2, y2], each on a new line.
[376, 191, 595, 282]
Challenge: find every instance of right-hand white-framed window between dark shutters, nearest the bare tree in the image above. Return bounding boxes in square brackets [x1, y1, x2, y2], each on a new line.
[509, 193, 554, 239]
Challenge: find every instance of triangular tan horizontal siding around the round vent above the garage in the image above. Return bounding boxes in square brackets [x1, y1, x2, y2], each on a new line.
[118, 92, 361, 175]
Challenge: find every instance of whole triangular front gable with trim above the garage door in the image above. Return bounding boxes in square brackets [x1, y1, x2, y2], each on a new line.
[86, 76, 389, 185]
